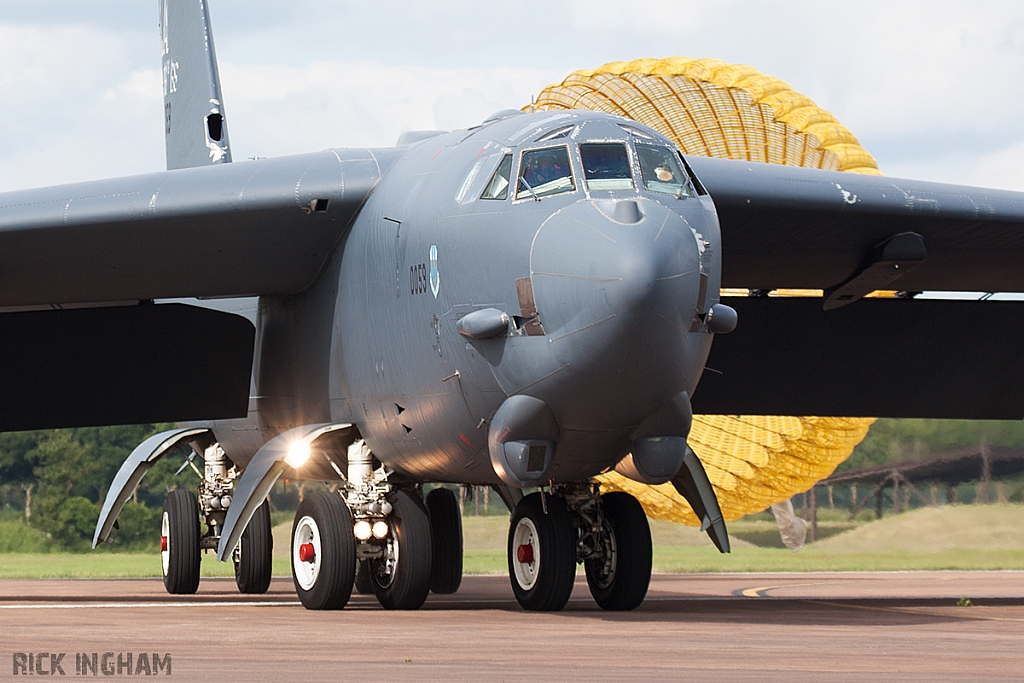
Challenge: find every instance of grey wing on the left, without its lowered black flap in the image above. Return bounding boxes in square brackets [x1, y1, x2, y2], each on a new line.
[0, 150, 395, 307]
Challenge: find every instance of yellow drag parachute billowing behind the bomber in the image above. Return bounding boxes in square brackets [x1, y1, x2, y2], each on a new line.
[534, 57, 881, 526]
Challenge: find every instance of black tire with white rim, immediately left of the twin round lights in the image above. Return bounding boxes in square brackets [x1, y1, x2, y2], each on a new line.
[291, 490, 355, 609]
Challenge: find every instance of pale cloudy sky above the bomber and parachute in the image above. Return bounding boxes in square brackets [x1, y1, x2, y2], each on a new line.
[0, 0, 1024, 191]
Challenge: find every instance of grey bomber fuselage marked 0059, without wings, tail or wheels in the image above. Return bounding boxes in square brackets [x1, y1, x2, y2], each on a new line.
[207, 112, 721, 484]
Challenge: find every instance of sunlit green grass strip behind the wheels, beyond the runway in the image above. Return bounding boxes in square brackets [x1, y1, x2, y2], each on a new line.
[0, 505, 1024, 579]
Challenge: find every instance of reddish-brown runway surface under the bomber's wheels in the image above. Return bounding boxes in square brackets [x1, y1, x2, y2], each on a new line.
[0, 571, 1024, 683]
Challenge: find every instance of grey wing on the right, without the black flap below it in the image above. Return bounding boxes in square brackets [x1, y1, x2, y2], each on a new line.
[686, 157, 1024, 298]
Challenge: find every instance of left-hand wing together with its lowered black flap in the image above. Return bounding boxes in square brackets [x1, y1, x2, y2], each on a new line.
[0, 150, 396, 431]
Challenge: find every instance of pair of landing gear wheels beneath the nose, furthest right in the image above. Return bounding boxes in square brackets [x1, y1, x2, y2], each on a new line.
[508, 484, 651, 611]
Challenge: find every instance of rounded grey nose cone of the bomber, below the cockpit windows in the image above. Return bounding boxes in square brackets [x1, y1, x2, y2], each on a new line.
[530, 200, 708, 429]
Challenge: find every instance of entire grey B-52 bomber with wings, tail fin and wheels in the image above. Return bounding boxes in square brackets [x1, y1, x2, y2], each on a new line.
[0, 0, 1024, 610]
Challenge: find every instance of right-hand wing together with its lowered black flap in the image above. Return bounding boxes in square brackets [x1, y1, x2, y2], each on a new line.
[687, 157, 1024, 419]
